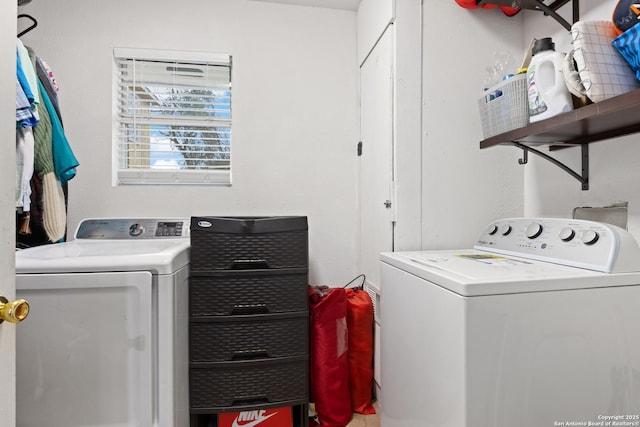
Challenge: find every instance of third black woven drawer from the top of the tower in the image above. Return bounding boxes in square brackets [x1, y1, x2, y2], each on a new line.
[189, 312, 309, 362]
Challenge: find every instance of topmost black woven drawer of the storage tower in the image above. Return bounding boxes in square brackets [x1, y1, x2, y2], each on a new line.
[191, 216, 309, 270]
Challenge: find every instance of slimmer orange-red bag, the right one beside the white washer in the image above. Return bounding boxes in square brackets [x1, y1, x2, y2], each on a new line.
[346, 289, 376, 415]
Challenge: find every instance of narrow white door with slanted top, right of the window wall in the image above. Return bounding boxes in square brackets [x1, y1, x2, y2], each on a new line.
[359, 27, 395, 289]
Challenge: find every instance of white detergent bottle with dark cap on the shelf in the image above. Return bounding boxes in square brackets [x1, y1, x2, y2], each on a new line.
[527, 37, 573, 122]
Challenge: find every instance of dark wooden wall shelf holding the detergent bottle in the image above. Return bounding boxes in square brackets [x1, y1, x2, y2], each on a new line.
[480, 89, 640, 148]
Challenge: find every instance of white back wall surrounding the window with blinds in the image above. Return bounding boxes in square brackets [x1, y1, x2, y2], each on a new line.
[21, 0, 357, 285]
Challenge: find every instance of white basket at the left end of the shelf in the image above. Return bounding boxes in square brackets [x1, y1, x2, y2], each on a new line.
[478, 74, 529, 139]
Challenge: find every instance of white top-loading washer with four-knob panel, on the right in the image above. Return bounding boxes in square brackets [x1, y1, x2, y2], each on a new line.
[380, 218, 640, 427]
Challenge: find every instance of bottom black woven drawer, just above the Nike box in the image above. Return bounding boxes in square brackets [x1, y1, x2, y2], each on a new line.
[189, 356, 309, 413]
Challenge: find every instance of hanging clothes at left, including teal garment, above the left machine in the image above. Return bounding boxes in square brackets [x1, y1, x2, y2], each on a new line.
[16, 35, 79, 247]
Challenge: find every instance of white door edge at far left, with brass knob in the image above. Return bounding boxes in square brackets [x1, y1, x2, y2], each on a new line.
[0, 1, 19, 427]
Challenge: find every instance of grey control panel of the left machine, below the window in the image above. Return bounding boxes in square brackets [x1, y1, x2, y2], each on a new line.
[75, 218, 190, 240]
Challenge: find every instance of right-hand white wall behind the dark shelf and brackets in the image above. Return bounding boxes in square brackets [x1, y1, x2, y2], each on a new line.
[524, 0, 640, 239]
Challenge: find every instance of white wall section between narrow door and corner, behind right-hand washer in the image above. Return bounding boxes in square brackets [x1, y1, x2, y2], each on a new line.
[422, 0, 523, 249]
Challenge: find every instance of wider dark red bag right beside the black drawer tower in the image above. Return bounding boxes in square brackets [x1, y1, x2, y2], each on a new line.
[309, 286, 353, 427]
